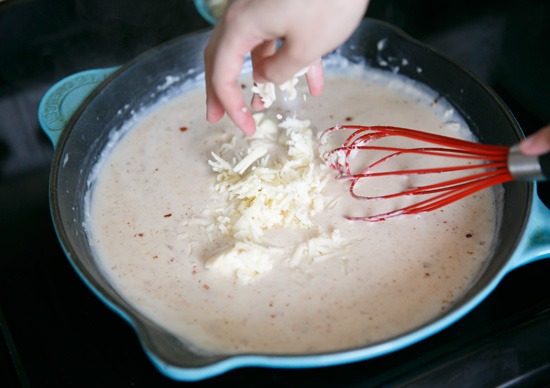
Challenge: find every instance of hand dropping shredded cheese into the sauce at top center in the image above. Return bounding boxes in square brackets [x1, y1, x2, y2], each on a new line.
[204, 0, 369, 135]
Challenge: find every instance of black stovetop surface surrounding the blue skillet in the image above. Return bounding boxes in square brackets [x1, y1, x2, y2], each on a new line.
[0, 0, 550, 387]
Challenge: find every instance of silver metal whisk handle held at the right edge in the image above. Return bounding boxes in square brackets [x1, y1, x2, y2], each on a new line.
[508, 145, 550, 181]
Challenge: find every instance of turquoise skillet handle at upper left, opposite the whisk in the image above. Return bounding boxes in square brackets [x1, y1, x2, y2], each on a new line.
[38, 66, 119, 148]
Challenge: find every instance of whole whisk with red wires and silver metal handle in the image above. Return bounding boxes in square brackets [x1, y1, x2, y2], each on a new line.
[319, 125, 550, 221]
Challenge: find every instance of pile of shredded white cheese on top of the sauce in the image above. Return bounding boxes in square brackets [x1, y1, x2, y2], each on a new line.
[206, 107, 343, 282]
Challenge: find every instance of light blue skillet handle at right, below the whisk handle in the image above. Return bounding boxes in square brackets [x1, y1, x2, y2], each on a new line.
[509, 195, 550, 271]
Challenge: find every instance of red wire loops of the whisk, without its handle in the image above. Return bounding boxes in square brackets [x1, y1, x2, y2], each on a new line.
[320, 125, 514, 221]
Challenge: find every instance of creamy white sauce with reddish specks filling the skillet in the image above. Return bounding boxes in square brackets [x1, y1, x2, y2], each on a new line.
[88, 64, 497, 354]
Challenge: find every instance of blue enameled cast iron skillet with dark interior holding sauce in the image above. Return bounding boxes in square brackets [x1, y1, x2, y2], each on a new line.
[39, 19, 550, 381]
